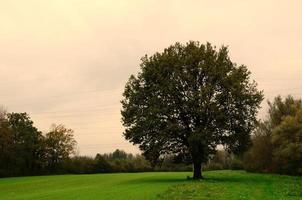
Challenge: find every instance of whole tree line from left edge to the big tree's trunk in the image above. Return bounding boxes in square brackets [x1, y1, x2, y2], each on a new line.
[0, 110, 196, 177]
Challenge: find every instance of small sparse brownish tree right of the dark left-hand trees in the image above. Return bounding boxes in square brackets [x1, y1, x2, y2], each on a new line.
[45, 124, 76, 172]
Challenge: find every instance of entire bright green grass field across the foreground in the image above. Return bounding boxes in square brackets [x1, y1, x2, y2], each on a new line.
[0, 171, 302, 200]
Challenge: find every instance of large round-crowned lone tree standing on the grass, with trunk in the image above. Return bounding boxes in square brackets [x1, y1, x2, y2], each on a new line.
[121, 42, 263, 179]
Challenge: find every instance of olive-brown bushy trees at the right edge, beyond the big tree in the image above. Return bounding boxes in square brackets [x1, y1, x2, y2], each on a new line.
[244, 95, 302, 174]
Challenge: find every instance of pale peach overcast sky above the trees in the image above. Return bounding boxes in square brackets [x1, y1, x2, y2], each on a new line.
[0, 0, 302, 156]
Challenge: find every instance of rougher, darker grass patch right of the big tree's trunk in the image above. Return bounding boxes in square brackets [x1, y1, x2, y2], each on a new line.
[159, 171, 302, 200]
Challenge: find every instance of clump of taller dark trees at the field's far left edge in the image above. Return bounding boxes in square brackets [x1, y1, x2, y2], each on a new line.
[0, 111, 76, 176]
